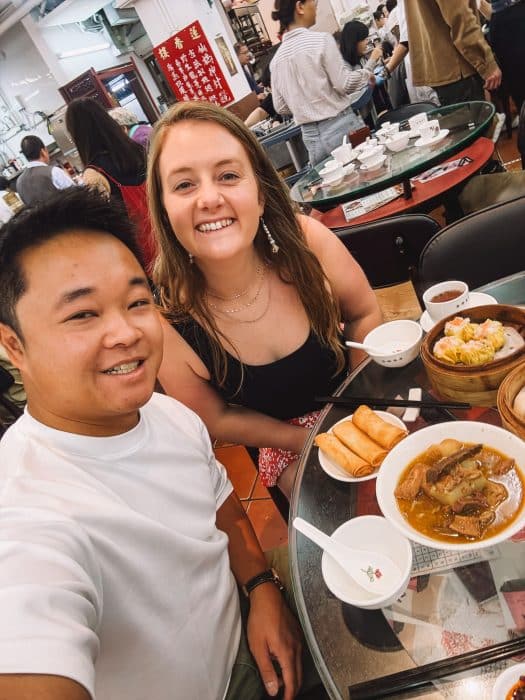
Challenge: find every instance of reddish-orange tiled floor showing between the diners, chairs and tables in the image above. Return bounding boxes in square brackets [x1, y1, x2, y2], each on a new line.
[216, 123, 521, 550]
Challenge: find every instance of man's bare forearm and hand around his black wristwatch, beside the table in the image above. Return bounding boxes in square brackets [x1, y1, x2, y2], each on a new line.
[215, 493, 302, 700]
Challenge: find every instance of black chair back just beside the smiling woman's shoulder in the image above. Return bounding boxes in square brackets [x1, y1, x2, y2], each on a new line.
[334, 214, 440, 289]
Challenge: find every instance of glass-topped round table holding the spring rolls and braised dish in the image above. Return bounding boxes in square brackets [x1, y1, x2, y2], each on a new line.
[289, 271, 525, 700]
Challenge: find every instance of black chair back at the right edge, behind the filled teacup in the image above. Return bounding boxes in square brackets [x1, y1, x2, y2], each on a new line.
[415, 196, 525, 299]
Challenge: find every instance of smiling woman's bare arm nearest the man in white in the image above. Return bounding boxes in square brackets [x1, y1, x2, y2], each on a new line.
[159, 321, 310, 453]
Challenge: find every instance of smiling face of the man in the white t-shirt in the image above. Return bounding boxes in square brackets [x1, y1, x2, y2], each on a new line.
[0, 231, 162, 436]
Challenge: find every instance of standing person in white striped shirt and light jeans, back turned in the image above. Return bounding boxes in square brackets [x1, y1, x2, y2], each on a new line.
[270, 0, 375, 165]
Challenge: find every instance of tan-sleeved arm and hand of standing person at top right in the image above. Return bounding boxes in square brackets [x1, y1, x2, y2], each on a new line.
[435, 0, 501, 90]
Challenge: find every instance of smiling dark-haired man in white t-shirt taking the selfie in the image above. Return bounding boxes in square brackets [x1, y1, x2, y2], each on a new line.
[0, 188, 301, 700]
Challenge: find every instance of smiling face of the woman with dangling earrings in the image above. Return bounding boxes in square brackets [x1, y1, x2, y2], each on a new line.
[159, 120, 264, 264]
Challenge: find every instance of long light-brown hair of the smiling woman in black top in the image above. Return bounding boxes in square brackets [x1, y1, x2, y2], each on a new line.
[147, 102, 345, 385]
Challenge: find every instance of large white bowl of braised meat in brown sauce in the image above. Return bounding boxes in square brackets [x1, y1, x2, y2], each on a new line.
[376, 421, 525, 550]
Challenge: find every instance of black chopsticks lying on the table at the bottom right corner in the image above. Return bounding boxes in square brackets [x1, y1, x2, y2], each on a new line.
[349, 637, 525, 700]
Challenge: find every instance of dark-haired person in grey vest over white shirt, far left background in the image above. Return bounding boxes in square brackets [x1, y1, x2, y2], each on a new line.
[16, 135, 75, 207]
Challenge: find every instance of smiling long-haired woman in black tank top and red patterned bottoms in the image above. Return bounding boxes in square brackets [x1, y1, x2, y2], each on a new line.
[148, 103, 381, 504]
